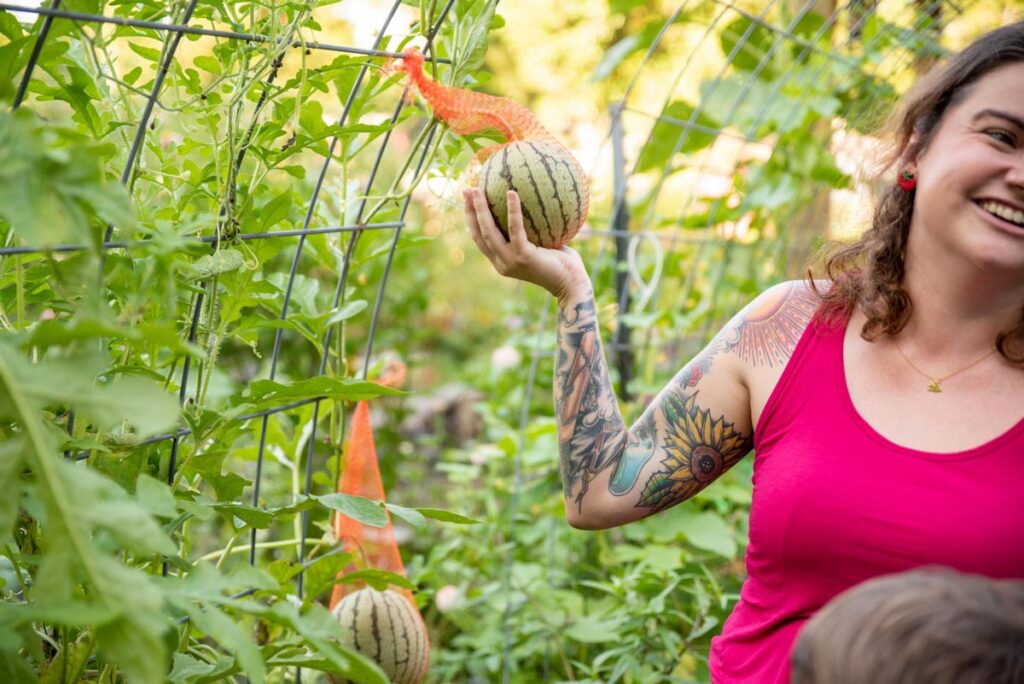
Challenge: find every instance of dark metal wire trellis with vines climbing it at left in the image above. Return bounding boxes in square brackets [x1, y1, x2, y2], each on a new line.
[0, 0, 455, 681]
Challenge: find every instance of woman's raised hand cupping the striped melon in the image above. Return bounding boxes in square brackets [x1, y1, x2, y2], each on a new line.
[463, 187, 591, 299]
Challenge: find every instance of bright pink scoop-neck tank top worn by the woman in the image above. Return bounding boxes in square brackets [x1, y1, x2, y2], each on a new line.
[710, 313, 1024, 684]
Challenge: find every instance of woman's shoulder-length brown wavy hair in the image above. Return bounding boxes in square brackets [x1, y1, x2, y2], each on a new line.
[808, 22, 1024, 364]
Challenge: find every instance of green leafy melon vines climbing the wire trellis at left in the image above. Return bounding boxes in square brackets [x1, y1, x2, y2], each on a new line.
[0, 0, 497, 684]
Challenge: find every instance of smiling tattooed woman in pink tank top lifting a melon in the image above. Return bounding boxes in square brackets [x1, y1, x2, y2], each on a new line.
[465, 24, 1024, 683]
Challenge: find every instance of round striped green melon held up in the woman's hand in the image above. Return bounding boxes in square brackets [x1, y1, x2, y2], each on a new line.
[479, 140, 590, 249]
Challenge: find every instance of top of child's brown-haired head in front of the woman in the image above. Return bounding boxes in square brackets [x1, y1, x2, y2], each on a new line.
[791, 568, 1024, 684]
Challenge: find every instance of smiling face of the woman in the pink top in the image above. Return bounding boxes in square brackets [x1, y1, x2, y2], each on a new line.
[911, 62, 1024, 275]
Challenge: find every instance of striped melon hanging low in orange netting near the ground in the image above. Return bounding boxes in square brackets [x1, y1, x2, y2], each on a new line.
[332, 587, 430, 684]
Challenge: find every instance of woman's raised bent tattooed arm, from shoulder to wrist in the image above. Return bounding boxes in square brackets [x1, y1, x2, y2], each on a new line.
[554, 283, 816, 528]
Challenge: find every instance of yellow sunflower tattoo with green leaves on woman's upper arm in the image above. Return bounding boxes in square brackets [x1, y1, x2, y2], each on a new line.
[638, 394, 751, 510]
